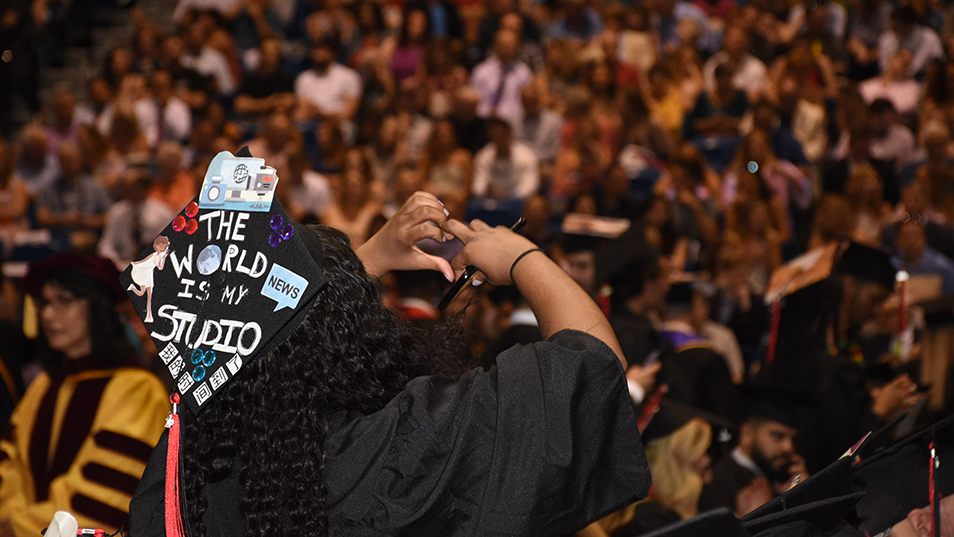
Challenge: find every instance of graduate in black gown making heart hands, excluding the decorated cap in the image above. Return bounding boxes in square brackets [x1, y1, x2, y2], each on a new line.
[131, 193, 650, 537]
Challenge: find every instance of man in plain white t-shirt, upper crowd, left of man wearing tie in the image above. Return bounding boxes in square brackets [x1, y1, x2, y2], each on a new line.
[295, 37, 362, 120]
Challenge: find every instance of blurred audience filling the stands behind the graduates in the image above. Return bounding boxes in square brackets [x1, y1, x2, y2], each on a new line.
[0, 0, 954, 532]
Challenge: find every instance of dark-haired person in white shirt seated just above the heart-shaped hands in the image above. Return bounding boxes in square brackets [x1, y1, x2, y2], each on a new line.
[471, 118, 540, 199]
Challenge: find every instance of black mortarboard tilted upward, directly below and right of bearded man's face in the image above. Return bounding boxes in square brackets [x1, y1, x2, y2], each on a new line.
[742, 457, 860, 533]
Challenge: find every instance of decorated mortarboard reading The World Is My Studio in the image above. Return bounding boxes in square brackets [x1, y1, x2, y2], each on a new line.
[120, 149, 327, 412]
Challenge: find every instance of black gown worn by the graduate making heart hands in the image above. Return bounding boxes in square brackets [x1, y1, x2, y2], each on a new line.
[130, 331, 650, 537]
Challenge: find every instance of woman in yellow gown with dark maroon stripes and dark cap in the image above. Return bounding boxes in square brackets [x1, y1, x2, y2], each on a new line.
[0, 253, 169, 537]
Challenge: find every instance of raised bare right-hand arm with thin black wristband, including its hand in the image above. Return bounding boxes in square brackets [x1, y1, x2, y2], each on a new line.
[444, 219, 626, 369]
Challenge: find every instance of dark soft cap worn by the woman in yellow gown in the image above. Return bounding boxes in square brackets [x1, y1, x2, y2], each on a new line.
[22, 252, 126, 303]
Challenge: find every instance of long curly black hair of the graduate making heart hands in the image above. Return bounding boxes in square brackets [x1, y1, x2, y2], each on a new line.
[182, 226, 464, 537]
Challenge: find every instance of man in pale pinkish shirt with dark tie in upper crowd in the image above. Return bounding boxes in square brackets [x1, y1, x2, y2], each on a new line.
[470, 29, 533, 119]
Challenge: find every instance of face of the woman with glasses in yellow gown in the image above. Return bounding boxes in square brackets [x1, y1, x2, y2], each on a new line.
[37, 283, 93, 358]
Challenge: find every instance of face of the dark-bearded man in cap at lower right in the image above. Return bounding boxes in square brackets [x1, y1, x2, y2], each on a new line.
[739, 420, 798, 481]
